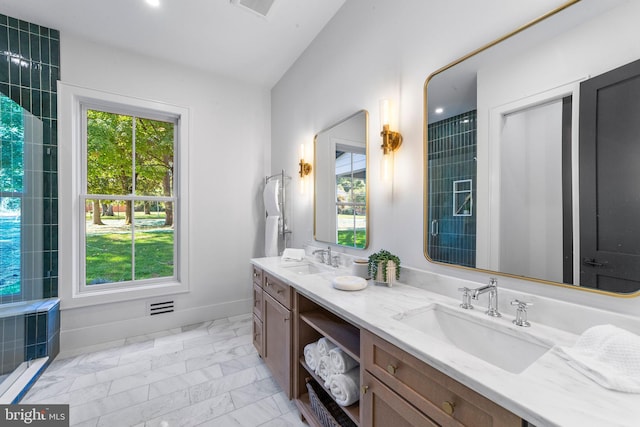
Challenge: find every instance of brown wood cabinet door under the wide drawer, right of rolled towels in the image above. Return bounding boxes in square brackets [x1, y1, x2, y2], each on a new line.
[360, 370, 439, 427]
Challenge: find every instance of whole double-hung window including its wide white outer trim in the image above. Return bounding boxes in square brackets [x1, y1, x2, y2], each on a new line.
[60, 85, 188, 302]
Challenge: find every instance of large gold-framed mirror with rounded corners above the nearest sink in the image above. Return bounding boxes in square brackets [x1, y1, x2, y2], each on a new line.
[424, 0, 640, 296]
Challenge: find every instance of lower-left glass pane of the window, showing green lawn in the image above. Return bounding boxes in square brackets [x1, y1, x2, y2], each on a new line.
[85, 200, 132, 285]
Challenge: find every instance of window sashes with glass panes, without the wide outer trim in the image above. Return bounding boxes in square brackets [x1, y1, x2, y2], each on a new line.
[80, 104, 177, 286]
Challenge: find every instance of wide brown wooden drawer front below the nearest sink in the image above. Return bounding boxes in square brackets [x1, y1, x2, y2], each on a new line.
[360, 330, 522, 427]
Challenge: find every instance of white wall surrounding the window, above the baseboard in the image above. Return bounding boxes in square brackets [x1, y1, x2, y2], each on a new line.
[59, 34, 270, 353]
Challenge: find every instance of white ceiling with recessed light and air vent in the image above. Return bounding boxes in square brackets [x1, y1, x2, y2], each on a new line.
[0, 0, 345, 88]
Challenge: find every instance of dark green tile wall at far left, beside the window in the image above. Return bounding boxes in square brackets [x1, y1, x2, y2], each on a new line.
[0, 15, 60, 298]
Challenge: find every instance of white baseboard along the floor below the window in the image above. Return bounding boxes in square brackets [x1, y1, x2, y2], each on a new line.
[58, 299, 253, 358]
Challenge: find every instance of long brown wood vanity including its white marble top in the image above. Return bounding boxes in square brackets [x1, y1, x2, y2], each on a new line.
[251, 258, 640, 427]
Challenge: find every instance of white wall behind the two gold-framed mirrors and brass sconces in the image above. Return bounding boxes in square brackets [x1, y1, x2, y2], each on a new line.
[271, 0, 640, 316]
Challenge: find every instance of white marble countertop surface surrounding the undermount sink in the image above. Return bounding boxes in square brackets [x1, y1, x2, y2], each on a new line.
[251, 257, 640, 427]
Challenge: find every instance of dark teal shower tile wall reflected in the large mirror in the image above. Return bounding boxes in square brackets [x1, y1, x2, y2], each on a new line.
[427, 111, 477, 267]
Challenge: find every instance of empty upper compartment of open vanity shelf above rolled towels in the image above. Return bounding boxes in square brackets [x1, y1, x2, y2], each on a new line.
[300, 309, 360, 362]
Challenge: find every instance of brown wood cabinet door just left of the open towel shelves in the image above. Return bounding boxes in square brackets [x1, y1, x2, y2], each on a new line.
[262, 293, 292, 399]
